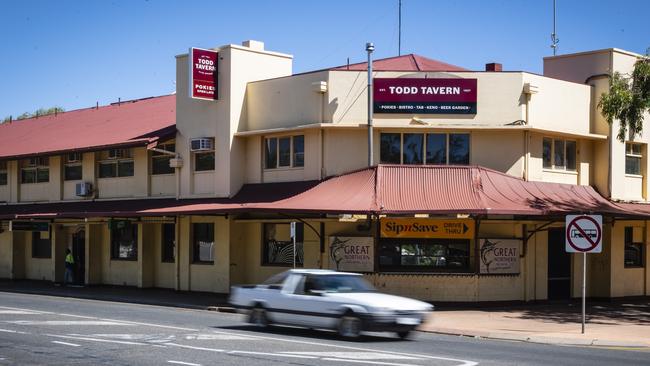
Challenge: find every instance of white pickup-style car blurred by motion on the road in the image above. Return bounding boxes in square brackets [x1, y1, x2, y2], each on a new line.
[229, 269, 433, 338]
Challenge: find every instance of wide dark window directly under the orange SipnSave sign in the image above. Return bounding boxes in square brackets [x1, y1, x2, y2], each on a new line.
[379, 239, 470, 272]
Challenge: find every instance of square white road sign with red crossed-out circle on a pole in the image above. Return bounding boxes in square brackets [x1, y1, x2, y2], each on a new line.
[566, 215, 603, 253]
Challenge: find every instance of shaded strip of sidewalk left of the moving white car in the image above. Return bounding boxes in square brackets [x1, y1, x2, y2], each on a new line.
[0, 280, 228, 310]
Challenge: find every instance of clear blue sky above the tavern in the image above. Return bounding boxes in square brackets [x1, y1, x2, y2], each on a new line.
[0, 0, 650, 118]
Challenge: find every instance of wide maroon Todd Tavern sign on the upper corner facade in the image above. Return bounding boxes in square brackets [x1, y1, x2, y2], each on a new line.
[373, 78, 477, 114]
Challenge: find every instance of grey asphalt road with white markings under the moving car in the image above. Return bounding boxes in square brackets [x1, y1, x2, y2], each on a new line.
[0, 293, 650, 366]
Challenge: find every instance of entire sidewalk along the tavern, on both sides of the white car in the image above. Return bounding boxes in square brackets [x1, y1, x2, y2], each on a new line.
[0, 280, 650, 350]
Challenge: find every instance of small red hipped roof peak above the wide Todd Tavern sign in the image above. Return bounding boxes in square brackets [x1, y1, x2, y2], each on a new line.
[330, 54, 468, 72]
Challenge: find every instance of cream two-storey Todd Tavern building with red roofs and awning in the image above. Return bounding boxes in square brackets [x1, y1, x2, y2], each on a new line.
[0, 41, 650, 302]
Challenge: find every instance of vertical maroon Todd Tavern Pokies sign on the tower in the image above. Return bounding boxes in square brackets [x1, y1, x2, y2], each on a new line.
[190, 48, 219, 100]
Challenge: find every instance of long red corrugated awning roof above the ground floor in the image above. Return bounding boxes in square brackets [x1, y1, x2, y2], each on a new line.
[0, 165, 636, 218]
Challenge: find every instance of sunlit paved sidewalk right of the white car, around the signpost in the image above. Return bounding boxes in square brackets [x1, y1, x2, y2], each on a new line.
[420, 298, 650, 348]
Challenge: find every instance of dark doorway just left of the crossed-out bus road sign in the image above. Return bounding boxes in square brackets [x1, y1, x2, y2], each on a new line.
[548, 228, 571, 300]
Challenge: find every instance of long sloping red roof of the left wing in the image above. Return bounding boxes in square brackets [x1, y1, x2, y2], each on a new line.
[0, 95, 176, 158]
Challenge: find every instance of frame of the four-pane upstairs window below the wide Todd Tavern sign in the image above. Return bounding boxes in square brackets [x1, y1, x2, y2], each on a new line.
[379, 132, 472, 166]
